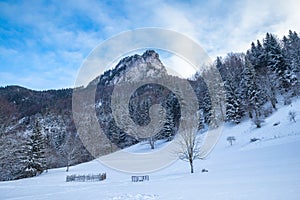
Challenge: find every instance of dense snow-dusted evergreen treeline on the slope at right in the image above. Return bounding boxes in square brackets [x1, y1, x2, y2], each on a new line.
[216, 31, 300, 127]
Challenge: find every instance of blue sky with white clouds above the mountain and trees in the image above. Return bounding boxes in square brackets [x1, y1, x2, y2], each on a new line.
[0, 0, 300, 90]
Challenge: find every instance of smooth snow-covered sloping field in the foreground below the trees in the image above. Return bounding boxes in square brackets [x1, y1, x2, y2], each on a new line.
[0, 101, 300, 200]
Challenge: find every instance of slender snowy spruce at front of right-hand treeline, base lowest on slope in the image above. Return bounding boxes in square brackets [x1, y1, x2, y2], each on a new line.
[243, 59, 263, 128]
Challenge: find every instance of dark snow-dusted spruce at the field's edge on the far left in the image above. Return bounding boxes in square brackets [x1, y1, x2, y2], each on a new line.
[21, 121, 46, 178]
